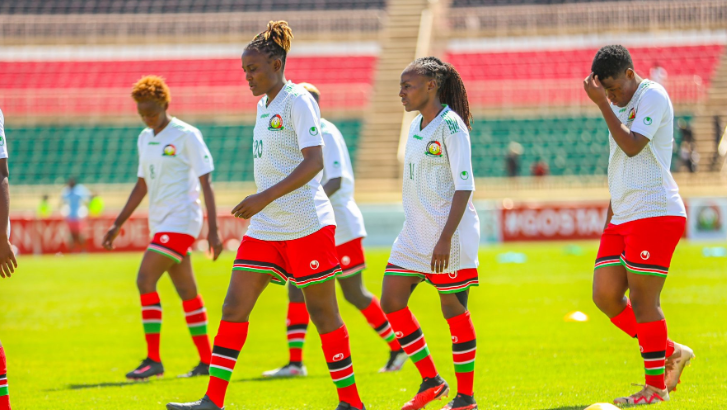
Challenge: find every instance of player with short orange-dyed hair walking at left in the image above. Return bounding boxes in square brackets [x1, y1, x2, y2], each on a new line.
[103, 76, 222, 380]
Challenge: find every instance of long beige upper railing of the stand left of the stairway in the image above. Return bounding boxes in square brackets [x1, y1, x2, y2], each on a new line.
[0, 10, 386, 44]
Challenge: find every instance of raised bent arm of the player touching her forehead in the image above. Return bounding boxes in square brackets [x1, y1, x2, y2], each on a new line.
[583, 73, 649, 157]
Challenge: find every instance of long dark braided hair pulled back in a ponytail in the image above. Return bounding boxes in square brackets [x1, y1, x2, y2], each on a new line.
[409, 57, 472, 129]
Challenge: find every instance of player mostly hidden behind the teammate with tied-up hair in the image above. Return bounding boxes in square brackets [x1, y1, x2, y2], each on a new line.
[263, 83, 407, 377]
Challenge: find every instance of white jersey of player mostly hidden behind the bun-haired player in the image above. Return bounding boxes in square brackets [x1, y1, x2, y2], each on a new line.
[321, 119, 366, 246]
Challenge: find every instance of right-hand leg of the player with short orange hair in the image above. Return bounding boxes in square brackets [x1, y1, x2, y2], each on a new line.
[169, 252, 212, 377]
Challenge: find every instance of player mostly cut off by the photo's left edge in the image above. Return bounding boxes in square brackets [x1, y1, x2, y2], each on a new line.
[0, 110, 18, 410]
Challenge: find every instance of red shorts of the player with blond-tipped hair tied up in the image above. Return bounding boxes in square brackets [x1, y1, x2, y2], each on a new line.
[232, 225, 341, 288]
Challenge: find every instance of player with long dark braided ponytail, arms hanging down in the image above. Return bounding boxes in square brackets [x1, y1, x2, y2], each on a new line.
[381, 57, 480, 410]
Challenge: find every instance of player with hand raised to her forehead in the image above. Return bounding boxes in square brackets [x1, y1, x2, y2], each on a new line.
[583, 45, 694, 404]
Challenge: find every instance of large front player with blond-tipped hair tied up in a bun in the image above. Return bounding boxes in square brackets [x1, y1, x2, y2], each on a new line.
[167, 21, 364, 410]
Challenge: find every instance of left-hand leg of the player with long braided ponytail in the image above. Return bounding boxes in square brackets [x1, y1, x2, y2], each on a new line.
[381, 264, 449, 410]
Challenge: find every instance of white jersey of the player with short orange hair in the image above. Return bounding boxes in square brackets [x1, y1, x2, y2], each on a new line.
[137, 118, 214, 238]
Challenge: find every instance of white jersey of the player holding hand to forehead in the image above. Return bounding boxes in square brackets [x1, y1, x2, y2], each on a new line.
[608, 80, 687, 225]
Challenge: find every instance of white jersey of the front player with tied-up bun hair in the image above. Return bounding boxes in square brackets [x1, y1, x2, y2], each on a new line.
[247, 82, 336, 241]
